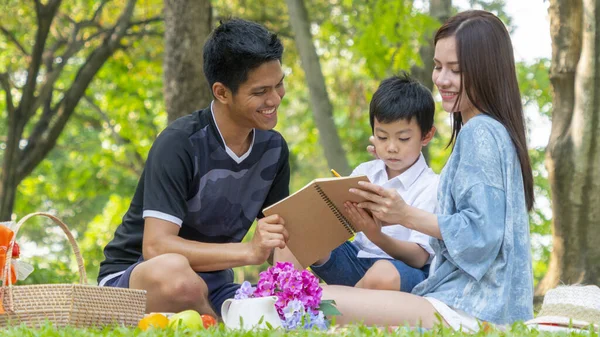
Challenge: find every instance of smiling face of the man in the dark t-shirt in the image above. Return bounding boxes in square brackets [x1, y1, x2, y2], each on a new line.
[230, 60, 285, 130]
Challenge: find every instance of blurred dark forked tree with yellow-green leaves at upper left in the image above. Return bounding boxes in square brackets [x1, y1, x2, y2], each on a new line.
[0, 0, 159, 220]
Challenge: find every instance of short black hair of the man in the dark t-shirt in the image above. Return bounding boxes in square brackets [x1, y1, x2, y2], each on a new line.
[203, 19, 283, 95]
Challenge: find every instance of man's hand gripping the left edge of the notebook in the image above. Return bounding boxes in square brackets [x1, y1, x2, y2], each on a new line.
[250, 214, 288, 264]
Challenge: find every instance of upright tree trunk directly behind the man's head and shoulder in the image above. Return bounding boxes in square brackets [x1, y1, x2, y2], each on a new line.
[163, 0, 212, 123]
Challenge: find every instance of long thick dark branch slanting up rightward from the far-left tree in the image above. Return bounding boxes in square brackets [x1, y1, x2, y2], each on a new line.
[17, 0, 136, 181]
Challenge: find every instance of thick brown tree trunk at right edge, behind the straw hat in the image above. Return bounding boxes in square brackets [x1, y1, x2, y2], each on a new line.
[536, 0, 600, 295]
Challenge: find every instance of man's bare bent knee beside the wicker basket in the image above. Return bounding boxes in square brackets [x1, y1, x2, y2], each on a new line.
[129, 254, 217, 317]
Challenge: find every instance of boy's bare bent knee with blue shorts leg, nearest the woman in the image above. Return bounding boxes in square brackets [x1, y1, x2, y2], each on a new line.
[356, 259, 429, 292]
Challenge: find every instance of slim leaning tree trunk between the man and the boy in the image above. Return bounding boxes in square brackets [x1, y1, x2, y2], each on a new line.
[286, 0, 351, 175]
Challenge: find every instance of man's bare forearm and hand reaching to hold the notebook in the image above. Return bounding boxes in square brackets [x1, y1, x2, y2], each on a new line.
[142, 215, 287, 272]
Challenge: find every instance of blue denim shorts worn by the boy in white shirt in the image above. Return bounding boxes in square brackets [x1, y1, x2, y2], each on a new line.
[310, 241, 429, 293]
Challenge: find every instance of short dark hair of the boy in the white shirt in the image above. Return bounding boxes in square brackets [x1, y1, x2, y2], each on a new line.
[369, 72, 435, 137]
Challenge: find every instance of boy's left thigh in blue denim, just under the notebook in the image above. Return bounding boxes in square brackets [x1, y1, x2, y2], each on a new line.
[310, 242, 371, 286]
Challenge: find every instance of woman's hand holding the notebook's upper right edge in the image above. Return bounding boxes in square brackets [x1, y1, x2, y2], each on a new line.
[350, 181, 410, 227]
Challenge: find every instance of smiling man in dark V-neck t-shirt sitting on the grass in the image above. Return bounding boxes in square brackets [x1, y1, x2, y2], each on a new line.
[98, 19, 290, 316]
